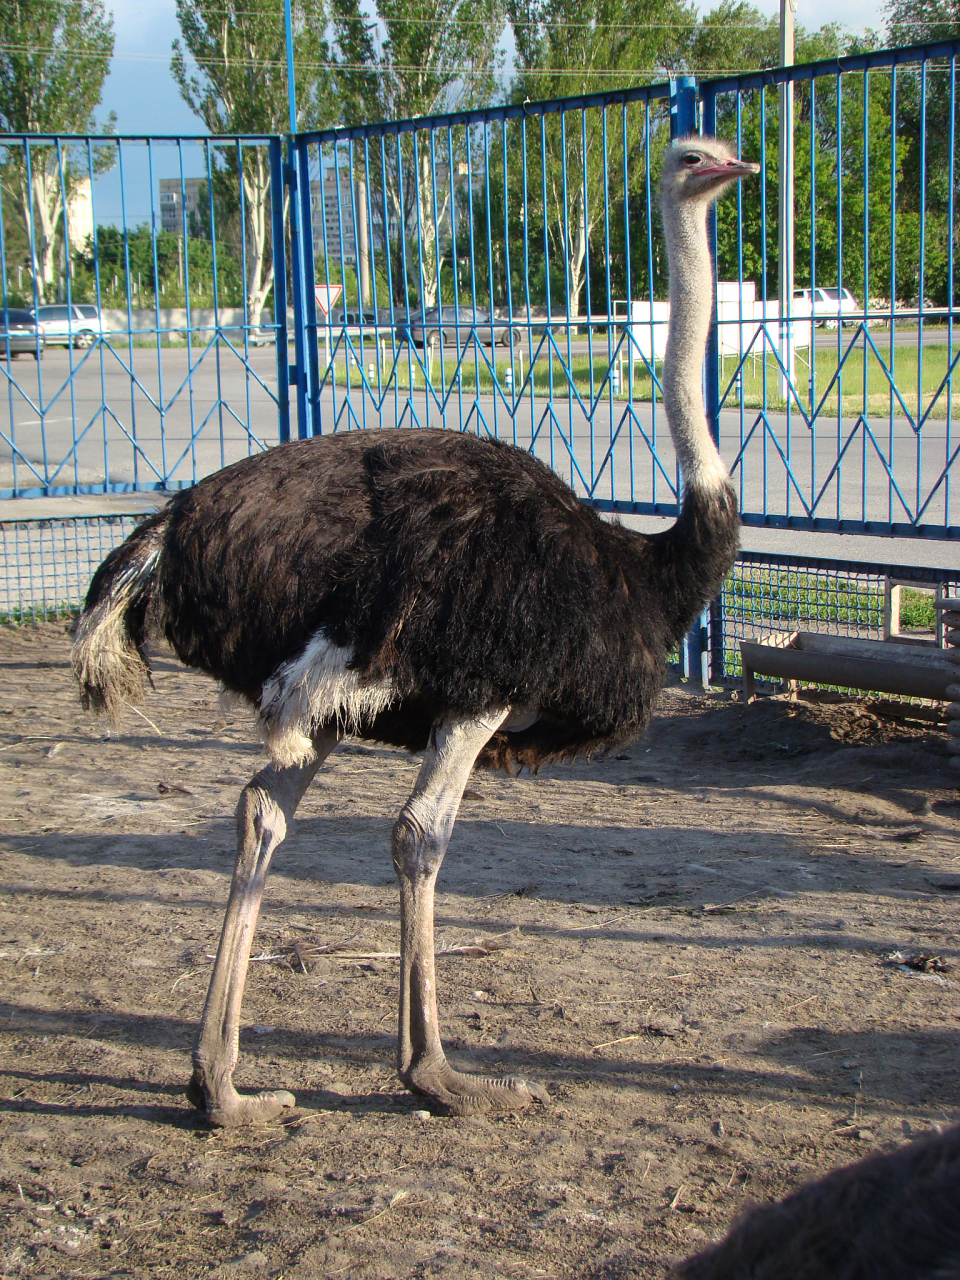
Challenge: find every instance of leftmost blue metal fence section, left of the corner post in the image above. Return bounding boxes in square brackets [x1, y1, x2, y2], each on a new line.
[0, 134, 289, 498]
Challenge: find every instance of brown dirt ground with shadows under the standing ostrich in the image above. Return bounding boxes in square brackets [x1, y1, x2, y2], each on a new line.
[0, 623, 960, 1280]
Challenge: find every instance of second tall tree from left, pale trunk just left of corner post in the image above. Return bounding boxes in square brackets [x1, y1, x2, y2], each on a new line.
[170, 0, 338, 325]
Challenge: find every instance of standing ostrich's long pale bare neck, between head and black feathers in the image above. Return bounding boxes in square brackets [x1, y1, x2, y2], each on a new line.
[663, 197, 728, 493]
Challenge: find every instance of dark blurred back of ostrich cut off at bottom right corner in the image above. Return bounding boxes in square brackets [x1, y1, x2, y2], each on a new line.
[671, 1125, 960, 1280]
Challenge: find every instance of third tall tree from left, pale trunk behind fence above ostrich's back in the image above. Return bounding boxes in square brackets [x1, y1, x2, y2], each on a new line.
[332, 0, 504, 307]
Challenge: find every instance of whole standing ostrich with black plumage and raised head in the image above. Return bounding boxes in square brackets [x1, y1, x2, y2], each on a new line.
[73, 137, 758, 1125]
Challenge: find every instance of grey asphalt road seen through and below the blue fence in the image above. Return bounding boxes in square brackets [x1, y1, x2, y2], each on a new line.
[0, 345, 960, 567]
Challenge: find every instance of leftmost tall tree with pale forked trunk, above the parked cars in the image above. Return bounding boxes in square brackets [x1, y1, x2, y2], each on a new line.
[0, 0, 114, 297]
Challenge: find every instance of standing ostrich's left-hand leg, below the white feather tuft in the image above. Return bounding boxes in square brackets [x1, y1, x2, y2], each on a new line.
[187, 732, 338, 1128]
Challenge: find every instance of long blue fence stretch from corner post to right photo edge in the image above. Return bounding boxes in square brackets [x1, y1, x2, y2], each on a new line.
[289, 42, 960, 538]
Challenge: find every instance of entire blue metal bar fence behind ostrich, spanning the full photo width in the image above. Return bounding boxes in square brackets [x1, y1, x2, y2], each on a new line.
[0, 41, 960, 673]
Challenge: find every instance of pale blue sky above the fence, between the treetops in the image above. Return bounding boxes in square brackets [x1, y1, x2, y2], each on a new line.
[99, 0, 883, 134]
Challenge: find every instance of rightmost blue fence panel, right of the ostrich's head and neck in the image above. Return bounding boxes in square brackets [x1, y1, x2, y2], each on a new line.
[700, 41, 960, 538]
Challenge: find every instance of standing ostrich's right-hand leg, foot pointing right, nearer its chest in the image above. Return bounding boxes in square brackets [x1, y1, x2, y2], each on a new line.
[393, 710, 548, 1114]
